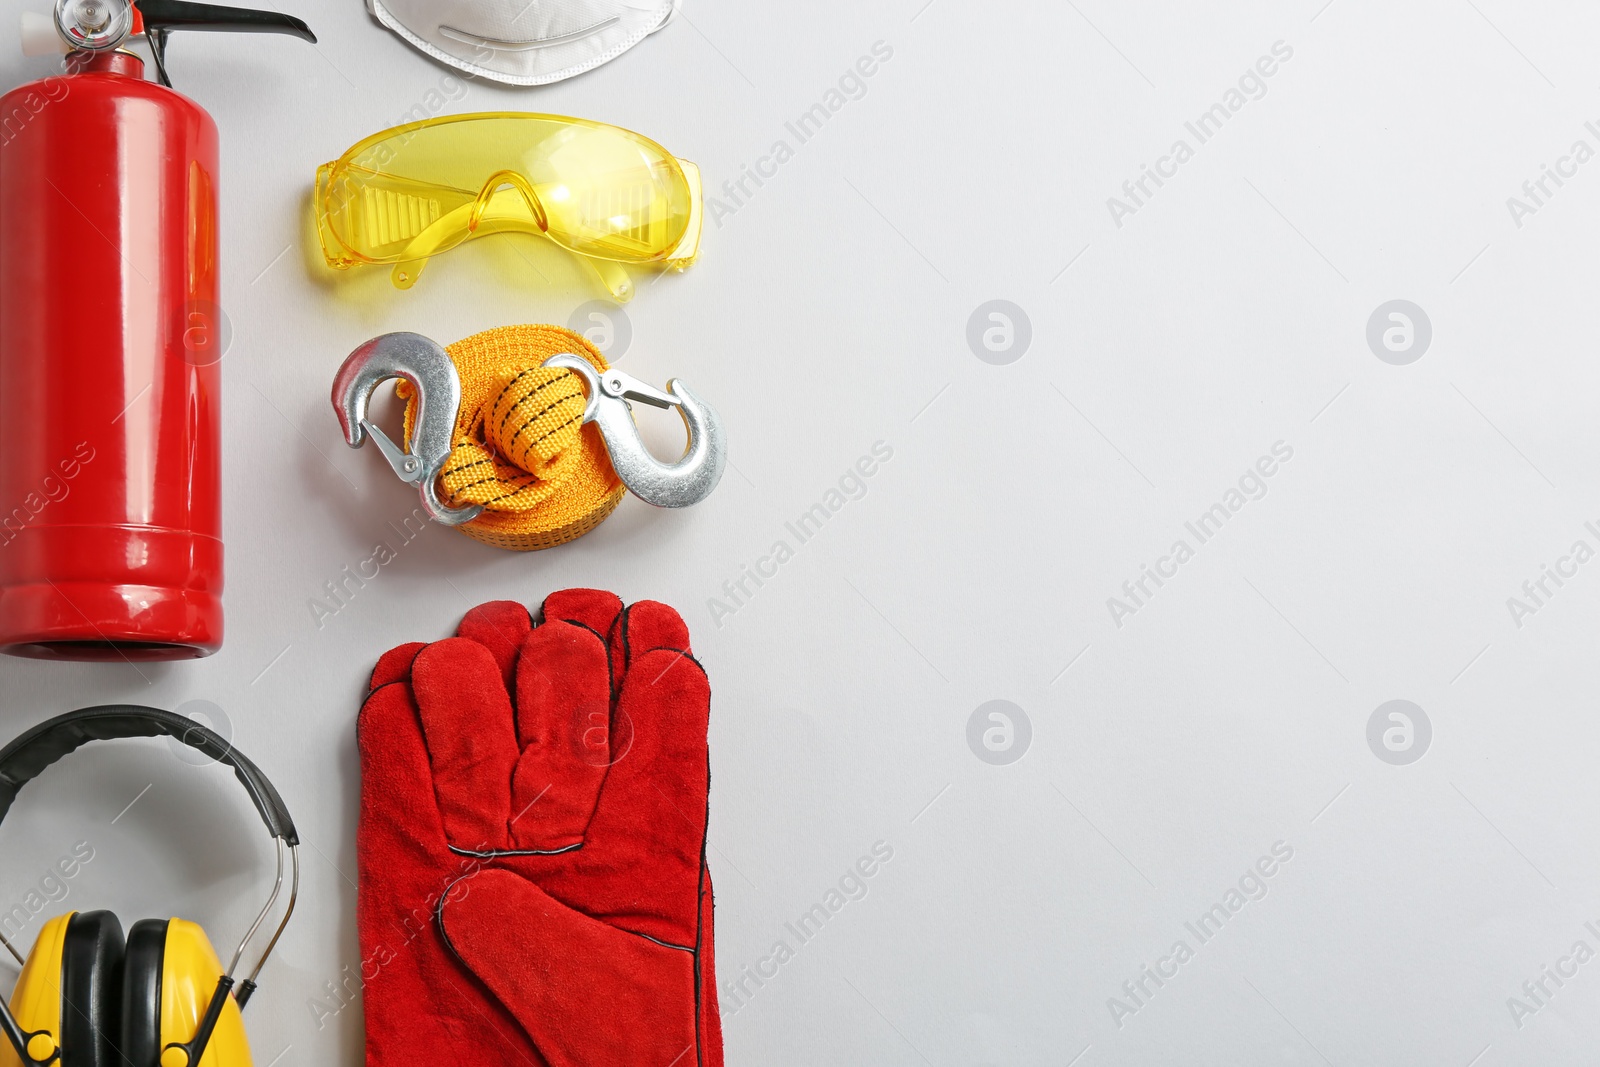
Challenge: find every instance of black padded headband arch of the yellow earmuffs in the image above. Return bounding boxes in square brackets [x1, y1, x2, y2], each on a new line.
[0, 704, 299, 846]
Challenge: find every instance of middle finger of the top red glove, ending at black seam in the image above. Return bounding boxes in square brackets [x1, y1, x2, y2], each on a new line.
[510, 619, 611, 851]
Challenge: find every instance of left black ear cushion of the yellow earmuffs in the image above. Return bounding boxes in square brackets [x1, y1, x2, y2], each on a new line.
[61, 912, 123, 1067]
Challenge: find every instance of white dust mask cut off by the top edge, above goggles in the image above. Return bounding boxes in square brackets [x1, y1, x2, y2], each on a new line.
[366, 0, 682, 85]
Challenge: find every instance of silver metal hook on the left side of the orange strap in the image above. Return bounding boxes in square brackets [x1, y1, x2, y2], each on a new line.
[333, 333, 483, 526]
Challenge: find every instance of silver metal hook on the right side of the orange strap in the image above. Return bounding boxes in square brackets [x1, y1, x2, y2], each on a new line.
[544, 354, 728, 507]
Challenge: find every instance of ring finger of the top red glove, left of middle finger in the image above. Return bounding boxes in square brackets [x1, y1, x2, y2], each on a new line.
[411, 637, 517, 853]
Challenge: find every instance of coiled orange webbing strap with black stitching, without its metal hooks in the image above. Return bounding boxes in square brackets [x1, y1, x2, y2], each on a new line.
[398, 326, 626, 552]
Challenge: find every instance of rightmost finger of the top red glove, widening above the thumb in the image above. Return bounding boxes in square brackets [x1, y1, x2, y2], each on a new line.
[541, 649, 710, 945]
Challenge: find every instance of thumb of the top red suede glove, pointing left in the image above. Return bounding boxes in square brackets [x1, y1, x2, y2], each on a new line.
[440, 870, 701, 1067]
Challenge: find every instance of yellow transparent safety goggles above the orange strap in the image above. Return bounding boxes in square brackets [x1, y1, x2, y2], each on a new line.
[315, 112, 702, 301]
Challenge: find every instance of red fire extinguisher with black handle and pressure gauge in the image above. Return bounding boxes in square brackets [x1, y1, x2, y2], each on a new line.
[0, 0, 317, 661]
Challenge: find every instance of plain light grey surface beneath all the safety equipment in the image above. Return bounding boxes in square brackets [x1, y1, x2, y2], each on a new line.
[0, 0, 1600, 1067]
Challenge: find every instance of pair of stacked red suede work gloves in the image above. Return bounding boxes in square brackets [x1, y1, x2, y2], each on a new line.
[357, 589, 722, 1067]
